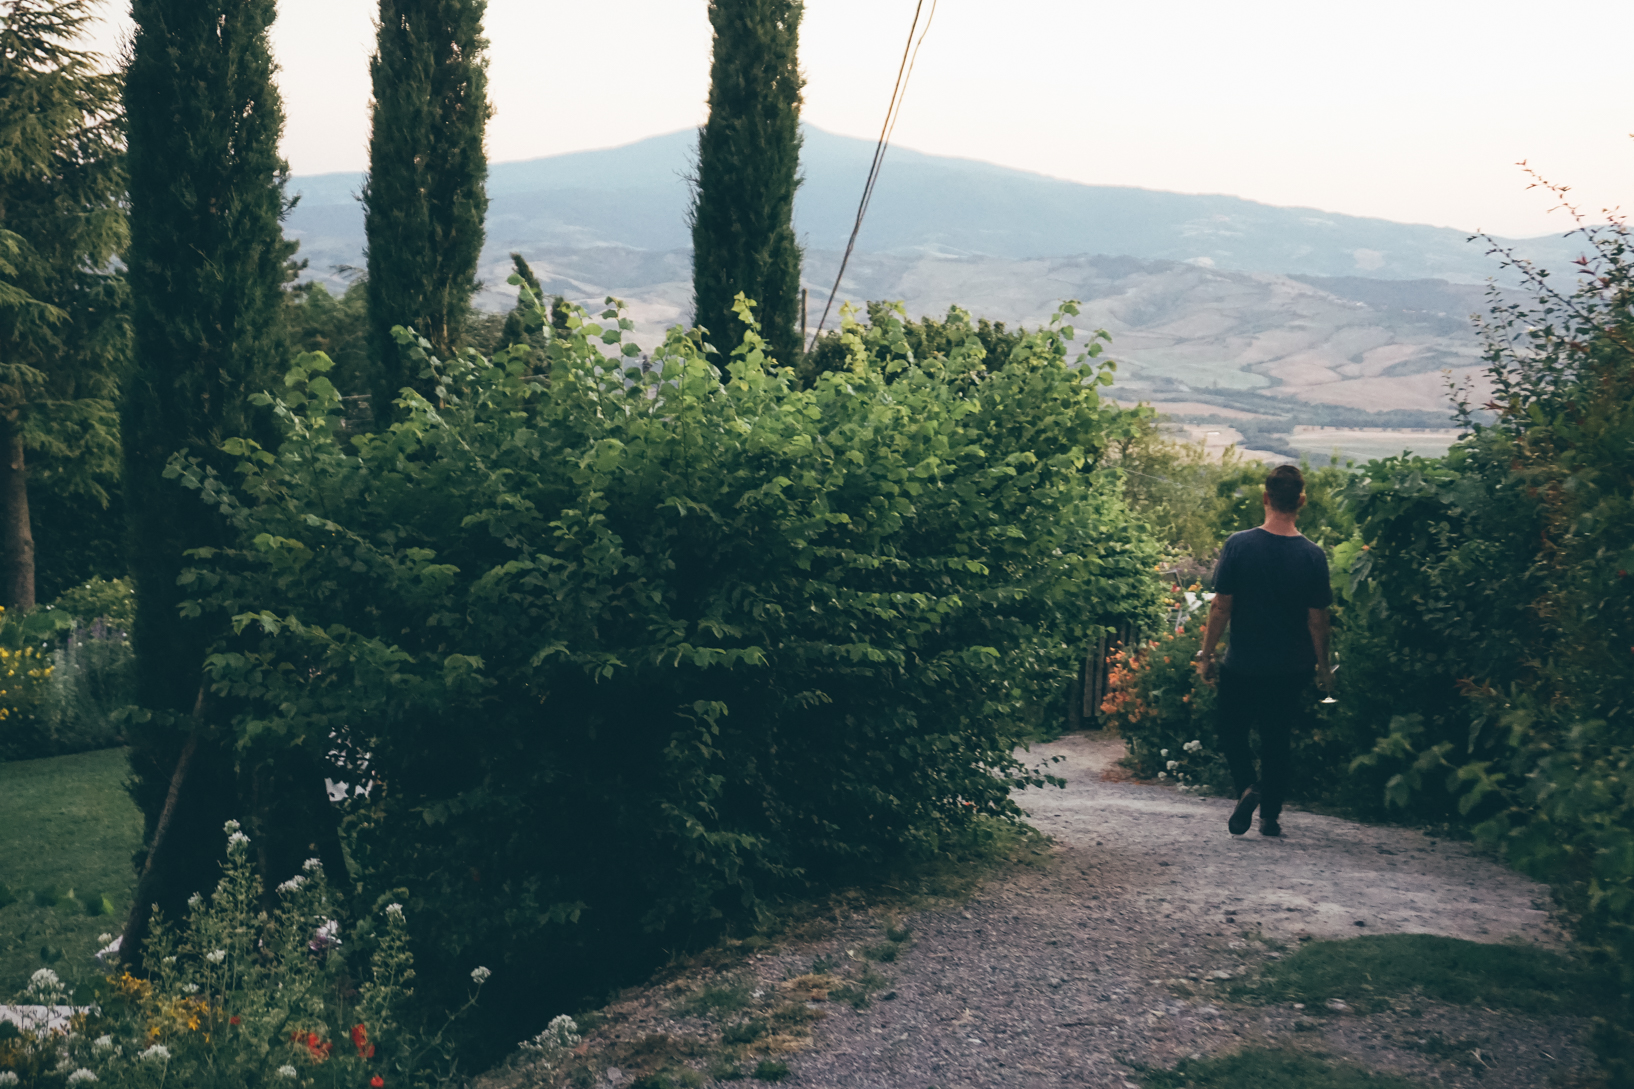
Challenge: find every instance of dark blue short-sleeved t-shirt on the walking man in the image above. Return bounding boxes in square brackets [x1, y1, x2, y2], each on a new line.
[1214, 530, 1333, 677]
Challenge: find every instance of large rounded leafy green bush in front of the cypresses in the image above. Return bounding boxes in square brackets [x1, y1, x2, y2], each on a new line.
[172, 292, 1157, 1038]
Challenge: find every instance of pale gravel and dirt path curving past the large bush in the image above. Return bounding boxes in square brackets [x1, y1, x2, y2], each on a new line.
[784, 737, 1587, 1089]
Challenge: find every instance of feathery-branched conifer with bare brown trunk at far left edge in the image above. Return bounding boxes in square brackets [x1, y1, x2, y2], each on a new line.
[0, 0, 127, 608]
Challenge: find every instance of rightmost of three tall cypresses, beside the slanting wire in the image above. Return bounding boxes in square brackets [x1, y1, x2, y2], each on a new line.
[690, 0, 804, 366]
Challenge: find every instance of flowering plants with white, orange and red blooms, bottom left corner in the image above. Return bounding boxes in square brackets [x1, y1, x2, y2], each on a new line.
[0, 821, 489, 1089]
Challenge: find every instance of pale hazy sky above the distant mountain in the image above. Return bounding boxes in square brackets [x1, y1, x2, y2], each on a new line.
[82, 0, 1634, 235]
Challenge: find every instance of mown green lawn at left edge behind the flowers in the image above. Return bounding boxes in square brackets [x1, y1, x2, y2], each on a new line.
[0, 749, 142, 1001]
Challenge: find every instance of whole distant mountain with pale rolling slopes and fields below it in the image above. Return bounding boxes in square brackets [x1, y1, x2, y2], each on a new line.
[288, 126, 1555, 424]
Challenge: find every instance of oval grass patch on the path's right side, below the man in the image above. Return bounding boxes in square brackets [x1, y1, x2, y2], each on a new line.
[1227, 934, 1614, 1015]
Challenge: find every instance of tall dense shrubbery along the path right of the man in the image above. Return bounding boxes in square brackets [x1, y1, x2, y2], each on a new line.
[1342, 209, 1634, 1086]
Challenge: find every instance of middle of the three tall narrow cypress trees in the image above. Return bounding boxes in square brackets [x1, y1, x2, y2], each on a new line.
[363, 0, 492, 422]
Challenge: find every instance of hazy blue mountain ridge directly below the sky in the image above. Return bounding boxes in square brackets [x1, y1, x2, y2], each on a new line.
[288, 126, 1572, 283]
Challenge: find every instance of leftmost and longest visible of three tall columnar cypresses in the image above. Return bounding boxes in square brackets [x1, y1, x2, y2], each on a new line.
[123, 0, 307, 957]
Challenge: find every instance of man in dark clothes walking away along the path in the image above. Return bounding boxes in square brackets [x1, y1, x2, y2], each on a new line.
[1198, 464, 1333, 836]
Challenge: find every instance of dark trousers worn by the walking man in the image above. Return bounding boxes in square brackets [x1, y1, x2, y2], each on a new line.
[1219, 669, 1310, 821]
